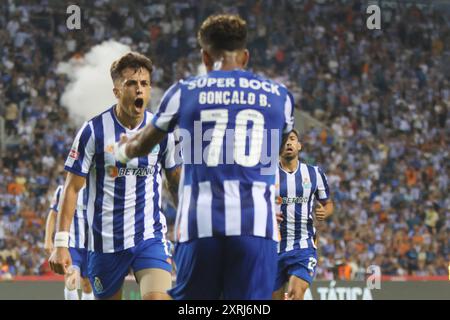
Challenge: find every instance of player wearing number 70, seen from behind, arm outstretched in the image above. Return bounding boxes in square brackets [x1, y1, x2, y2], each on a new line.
[115, 15, 294, 299]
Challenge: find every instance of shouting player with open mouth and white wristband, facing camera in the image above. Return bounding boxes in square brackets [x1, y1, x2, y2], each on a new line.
[49, 52, 180, 300]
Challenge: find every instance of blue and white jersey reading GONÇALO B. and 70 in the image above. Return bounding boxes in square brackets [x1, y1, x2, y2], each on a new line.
[152, 70, 294, 242]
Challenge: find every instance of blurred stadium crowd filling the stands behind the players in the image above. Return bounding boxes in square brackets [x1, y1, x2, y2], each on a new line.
[0, 0, 450, 279]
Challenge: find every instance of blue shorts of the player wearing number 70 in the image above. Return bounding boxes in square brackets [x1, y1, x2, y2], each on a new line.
[168, 236, 277, 300]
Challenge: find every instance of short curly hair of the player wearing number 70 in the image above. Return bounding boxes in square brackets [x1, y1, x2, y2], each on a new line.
[197, 14, 247, 55]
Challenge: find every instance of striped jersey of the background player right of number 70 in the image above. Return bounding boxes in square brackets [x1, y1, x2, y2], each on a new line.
[276, 161, 330, 253]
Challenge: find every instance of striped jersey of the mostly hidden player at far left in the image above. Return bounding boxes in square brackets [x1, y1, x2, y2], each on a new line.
[50, 185, 88, 249]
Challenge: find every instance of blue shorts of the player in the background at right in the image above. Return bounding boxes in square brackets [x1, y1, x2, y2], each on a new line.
[274, 248, 317, 291]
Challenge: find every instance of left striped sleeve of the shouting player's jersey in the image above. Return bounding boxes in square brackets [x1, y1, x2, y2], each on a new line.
[64, 122, 95, 177]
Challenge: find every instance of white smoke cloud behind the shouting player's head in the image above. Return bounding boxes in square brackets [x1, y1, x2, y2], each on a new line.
[56, 40, 131, 123]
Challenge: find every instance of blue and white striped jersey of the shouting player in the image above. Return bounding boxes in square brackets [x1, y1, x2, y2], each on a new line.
[65, 106, 180, 253]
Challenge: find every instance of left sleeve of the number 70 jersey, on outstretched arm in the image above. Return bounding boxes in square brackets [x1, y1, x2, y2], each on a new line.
[152, 82, 181, 132]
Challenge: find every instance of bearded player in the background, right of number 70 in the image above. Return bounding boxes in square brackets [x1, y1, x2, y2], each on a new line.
[272, 129, 333, 300]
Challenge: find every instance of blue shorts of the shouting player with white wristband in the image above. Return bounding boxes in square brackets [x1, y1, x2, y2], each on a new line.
[88, 238, 172, 299]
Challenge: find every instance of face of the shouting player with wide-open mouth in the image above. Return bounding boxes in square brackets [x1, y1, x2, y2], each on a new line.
[114, 68, 151, 118]
